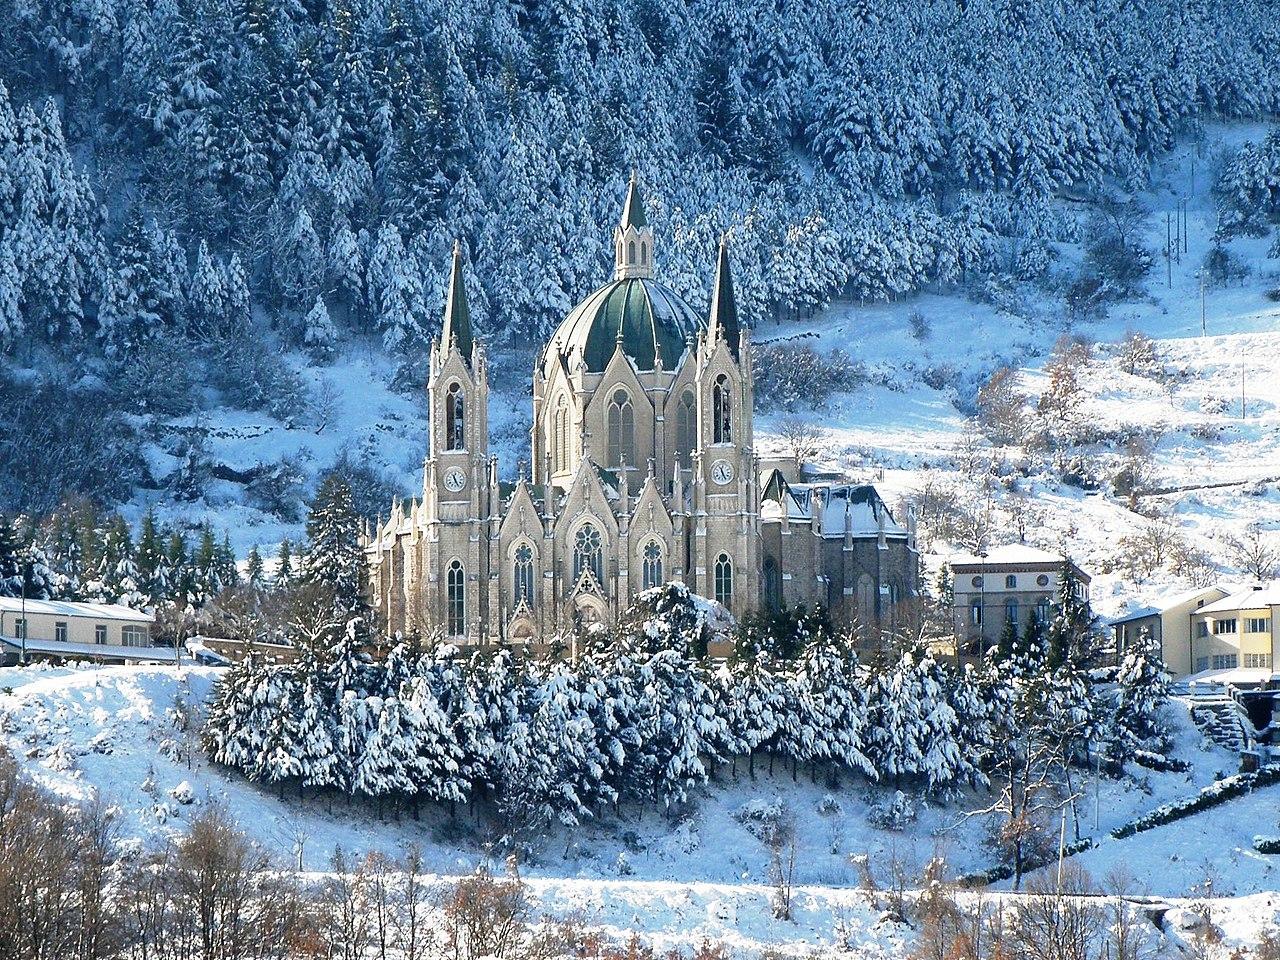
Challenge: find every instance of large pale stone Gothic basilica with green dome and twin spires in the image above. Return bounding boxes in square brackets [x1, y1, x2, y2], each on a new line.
[364, 177, 919, 646]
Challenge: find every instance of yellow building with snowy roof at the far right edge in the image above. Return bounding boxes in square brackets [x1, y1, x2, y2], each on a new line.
[1190, 581, 1280, 673]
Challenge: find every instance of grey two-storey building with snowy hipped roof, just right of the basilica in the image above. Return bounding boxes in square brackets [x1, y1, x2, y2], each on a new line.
[948, 544, 1089, 655]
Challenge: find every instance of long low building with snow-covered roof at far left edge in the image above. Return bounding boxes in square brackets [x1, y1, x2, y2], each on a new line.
[0, 596, 175, 664]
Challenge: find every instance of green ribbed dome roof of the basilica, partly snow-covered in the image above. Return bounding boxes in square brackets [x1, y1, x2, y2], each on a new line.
[543, 276, 704, 375]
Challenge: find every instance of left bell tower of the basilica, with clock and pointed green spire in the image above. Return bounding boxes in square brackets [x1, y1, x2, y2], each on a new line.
[415, 242, 498, 643]
